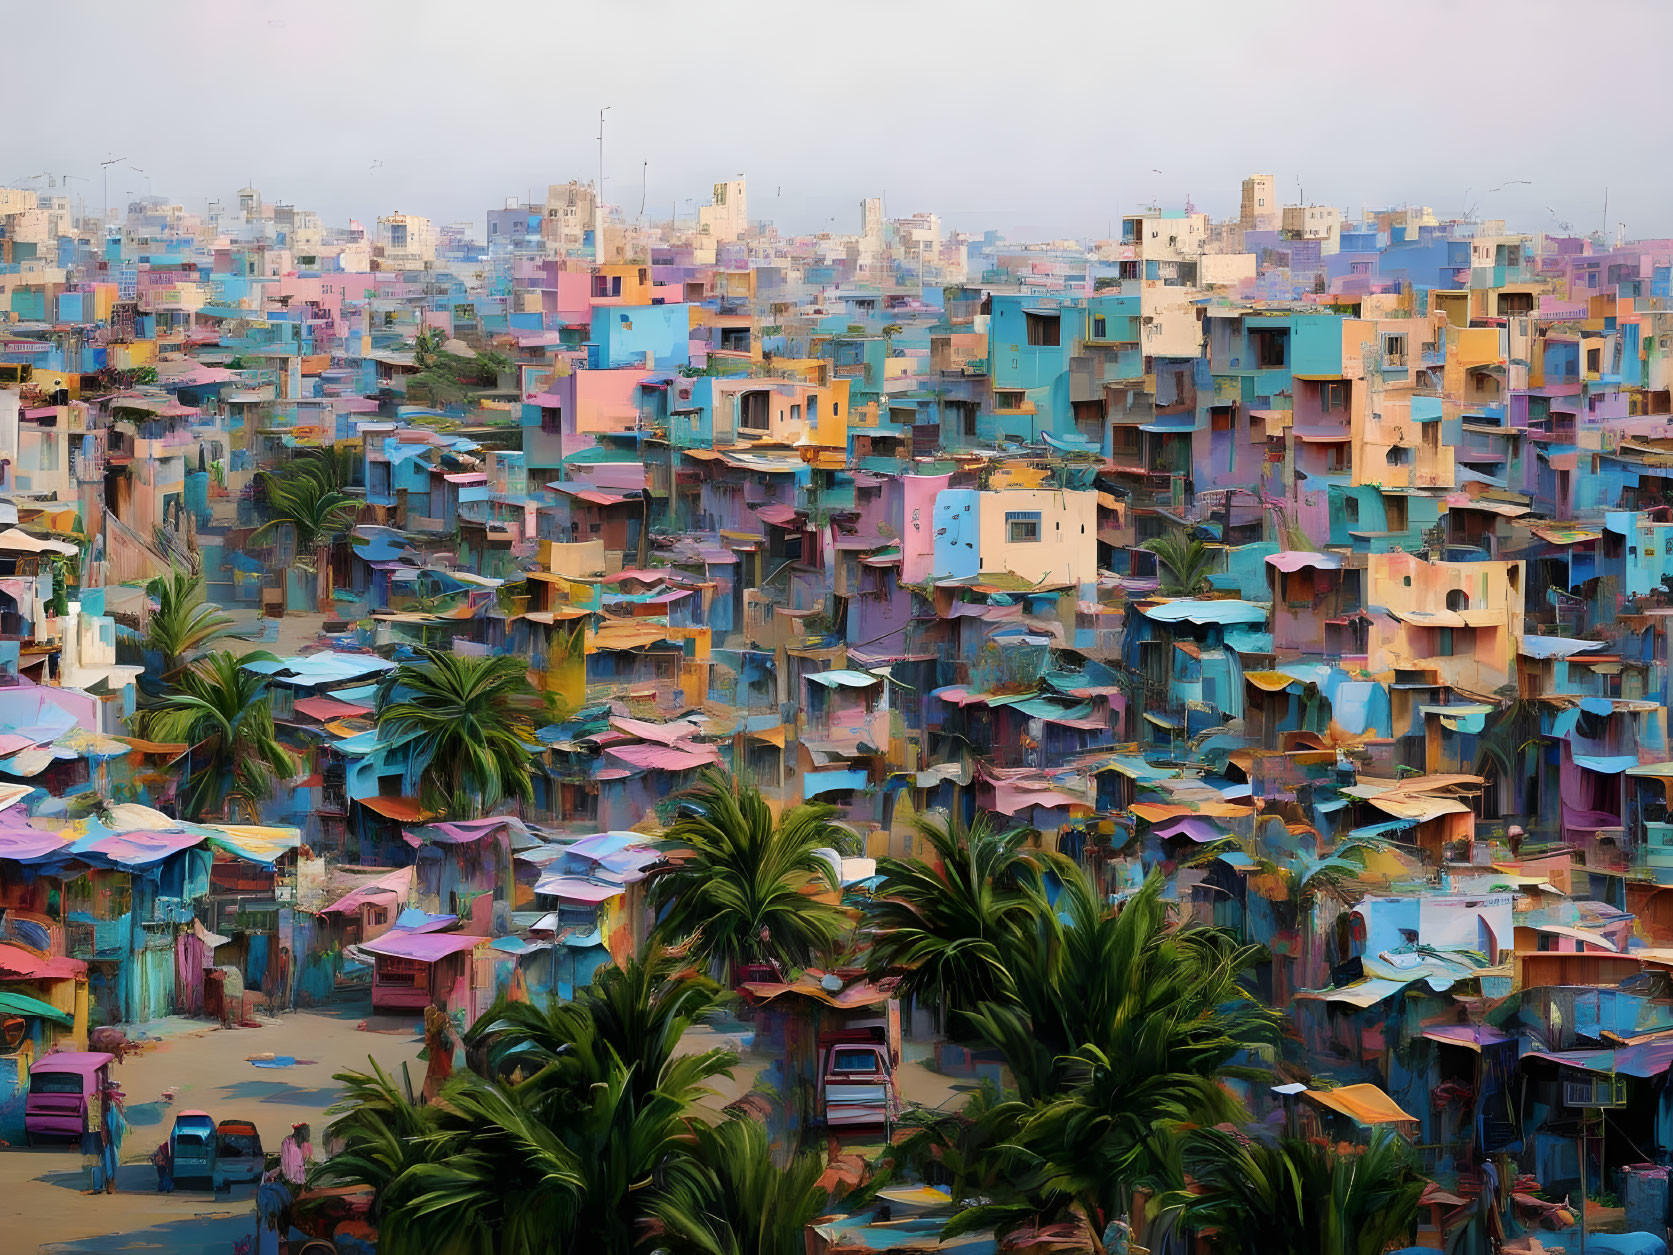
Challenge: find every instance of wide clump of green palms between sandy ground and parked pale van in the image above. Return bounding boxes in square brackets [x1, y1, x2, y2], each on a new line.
[326, 950, 825, 1255]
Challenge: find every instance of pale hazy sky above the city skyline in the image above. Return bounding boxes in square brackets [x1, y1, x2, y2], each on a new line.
[0, 0, 1673, 238]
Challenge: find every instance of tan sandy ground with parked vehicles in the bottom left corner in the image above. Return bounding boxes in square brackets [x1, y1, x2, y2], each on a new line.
[0, 1009, 423, 1255]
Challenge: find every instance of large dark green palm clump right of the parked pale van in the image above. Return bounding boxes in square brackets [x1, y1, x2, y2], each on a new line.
[882, 863, 1280, 1235]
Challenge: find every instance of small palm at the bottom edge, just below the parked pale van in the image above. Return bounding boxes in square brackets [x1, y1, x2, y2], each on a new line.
[651, 1119, 828, 1255]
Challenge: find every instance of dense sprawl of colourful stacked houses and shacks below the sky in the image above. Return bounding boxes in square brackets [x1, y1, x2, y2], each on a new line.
[0, 177, 1673, 1244]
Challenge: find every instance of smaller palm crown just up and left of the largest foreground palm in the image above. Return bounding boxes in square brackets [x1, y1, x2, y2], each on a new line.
[865, 813, 1047, 1039]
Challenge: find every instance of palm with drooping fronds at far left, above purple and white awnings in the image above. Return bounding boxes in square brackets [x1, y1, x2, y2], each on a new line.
[137, 651, 299, 818]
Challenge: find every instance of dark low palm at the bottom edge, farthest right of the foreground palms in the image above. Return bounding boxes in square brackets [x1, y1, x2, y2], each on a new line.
[1158, 1128, 1424, 1255]
